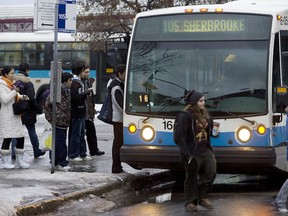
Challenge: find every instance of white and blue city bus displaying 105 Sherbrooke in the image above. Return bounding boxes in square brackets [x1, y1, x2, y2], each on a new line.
[121, 0, 288, 173]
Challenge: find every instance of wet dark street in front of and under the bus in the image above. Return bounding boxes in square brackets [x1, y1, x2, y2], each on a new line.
[41, 175, 283, 216]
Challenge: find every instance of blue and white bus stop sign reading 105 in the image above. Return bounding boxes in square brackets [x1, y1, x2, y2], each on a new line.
[58, 1, 77, 33]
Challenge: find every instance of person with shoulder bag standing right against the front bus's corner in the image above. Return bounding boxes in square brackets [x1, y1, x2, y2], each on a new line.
[107, 64, 126, 173]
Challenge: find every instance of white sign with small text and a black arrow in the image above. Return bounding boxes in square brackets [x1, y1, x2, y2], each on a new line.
[34, 0, 56, 30]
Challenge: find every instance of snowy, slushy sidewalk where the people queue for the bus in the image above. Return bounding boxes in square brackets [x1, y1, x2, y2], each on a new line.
[0, 109, 167, 216]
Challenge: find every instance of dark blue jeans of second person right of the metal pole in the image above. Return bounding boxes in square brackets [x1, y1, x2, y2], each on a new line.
[68, 118, 87, 159]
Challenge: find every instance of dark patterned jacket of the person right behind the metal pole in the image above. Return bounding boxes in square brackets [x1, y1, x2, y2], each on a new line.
[44, 84, 71, 127]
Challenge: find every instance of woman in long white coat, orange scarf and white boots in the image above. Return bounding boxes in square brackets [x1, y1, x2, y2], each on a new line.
[0, 66, 29, 169]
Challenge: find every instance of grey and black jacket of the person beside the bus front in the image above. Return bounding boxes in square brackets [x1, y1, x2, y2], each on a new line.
[107, 77, 124, 122]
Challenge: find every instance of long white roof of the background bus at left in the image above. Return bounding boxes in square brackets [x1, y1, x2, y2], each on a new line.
[0, 31, 76, 42]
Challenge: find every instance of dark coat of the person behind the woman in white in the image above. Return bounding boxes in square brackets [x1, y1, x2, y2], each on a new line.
[15, 71, 37, 124]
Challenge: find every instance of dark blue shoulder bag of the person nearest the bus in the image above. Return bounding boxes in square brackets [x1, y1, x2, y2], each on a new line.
[97, 79, 119, 124]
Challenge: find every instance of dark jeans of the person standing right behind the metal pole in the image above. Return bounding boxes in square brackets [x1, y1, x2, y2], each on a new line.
[50, 127, 69, 167]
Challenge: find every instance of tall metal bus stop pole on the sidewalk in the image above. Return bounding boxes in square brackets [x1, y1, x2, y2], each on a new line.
[51, 0, 59, 173]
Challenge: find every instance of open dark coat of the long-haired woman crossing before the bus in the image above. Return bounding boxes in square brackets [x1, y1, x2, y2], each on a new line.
[177, 112, 213, 161]
